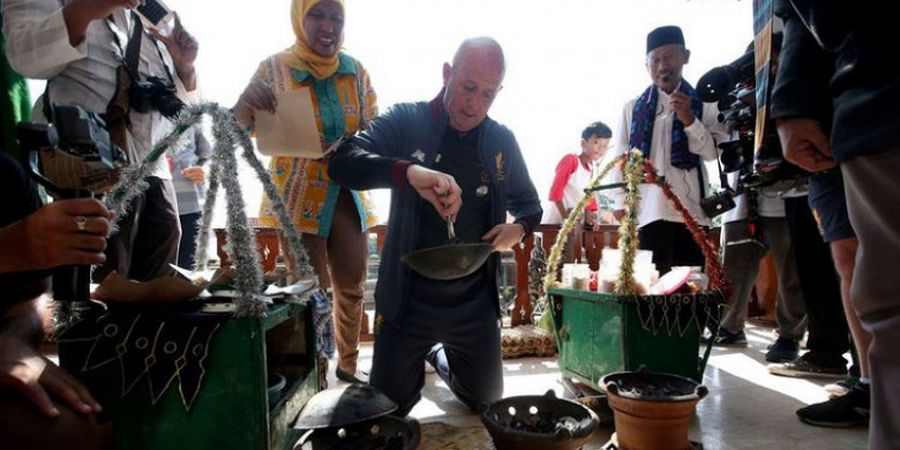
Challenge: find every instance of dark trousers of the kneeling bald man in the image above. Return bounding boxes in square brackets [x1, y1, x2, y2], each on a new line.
[369, 289, 503, 416]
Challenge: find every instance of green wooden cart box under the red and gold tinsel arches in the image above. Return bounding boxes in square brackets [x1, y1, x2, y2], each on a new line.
[548, 288, 722, 389]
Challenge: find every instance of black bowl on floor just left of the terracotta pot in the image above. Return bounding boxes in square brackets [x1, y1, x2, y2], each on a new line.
[481, 390, 598, 450]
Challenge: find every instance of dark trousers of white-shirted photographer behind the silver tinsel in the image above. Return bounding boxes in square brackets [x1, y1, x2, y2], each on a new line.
[93, 177, 181, 283]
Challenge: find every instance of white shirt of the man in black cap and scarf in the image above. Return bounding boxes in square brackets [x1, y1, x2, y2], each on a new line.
[609, 84, 727, 227]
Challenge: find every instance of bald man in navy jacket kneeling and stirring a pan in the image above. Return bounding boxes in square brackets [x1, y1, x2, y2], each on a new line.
[329, 38, 541, 414]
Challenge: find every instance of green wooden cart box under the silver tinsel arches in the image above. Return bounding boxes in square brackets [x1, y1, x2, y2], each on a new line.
[59, 303, 320, 450]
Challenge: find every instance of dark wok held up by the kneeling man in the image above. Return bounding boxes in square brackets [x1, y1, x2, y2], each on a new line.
[401, 242, 494, 280]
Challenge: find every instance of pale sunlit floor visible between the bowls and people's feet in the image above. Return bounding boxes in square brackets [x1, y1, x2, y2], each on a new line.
[329, 325, 866, 450]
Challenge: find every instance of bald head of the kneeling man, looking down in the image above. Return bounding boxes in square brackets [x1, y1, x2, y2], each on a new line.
[444, 37, 506, 132]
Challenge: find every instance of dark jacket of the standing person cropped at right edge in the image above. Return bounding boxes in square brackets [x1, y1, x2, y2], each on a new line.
[772, 0, 900, 161]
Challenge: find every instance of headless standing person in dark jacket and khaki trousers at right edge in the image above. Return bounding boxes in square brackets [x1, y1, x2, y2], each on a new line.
[772, 0, 900, 449]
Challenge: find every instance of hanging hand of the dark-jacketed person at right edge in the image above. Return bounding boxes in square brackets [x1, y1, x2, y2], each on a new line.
[775, 117, 837, 172]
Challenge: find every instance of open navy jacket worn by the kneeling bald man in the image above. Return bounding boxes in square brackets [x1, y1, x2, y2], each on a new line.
[328, 97, 542, 327]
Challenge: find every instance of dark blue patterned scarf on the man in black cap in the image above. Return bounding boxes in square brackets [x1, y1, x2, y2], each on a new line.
[628, 80, 703, 170]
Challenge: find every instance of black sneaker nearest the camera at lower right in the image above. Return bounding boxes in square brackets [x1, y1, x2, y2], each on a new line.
[797, 385, 870, 428]
